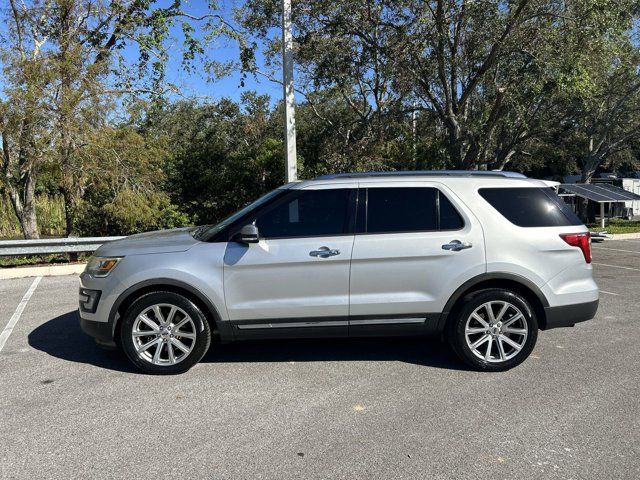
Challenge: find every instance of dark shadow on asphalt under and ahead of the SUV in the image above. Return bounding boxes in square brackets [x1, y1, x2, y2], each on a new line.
[28, 311, 466, 373]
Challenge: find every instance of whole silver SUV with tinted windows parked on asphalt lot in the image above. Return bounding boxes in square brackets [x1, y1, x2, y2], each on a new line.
[79, 171, 598, 373]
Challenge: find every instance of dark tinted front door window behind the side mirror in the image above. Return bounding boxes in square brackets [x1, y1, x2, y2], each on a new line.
[256, 189, 349, 238]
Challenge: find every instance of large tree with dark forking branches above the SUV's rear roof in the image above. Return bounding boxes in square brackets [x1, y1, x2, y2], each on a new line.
[398, 0, 580, 168]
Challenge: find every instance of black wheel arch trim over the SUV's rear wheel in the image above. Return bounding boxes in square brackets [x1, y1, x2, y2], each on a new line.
[438, 272, 549, 332]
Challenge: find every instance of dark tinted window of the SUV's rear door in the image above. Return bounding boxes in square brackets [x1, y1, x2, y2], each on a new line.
[365, 187, 463, 233]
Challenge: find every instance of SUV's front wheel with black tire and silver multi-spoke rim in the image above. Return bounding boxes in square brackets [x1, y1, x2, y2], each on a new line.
[120, 291, 211, 375]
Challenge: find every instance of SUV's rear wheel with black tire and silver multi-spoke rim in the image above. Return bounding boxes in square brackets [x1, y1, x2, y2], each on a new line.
[448, 289, 538, 372]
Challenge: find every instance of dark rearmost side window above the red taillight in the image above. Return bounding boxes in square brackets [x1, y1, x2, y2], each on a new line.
[480, 187, 582, 227]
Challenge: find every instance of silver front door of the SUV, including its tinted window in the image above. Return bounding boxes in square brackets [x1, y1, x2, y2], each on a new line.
[224, 185, 356, 338]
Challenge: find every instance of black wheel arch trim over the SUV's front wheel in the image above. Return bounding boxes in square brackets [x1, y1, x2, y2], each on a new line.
[109, 278, 233, 342]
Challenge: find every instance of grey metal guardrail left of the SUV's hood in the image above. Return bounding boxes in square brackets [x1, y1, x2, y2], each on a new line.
[0, 237, 125, 257]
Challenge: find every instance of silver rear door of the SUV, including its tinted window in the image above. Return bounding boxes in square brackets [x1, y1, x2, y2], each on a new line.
[349, 181, 486, 335]
